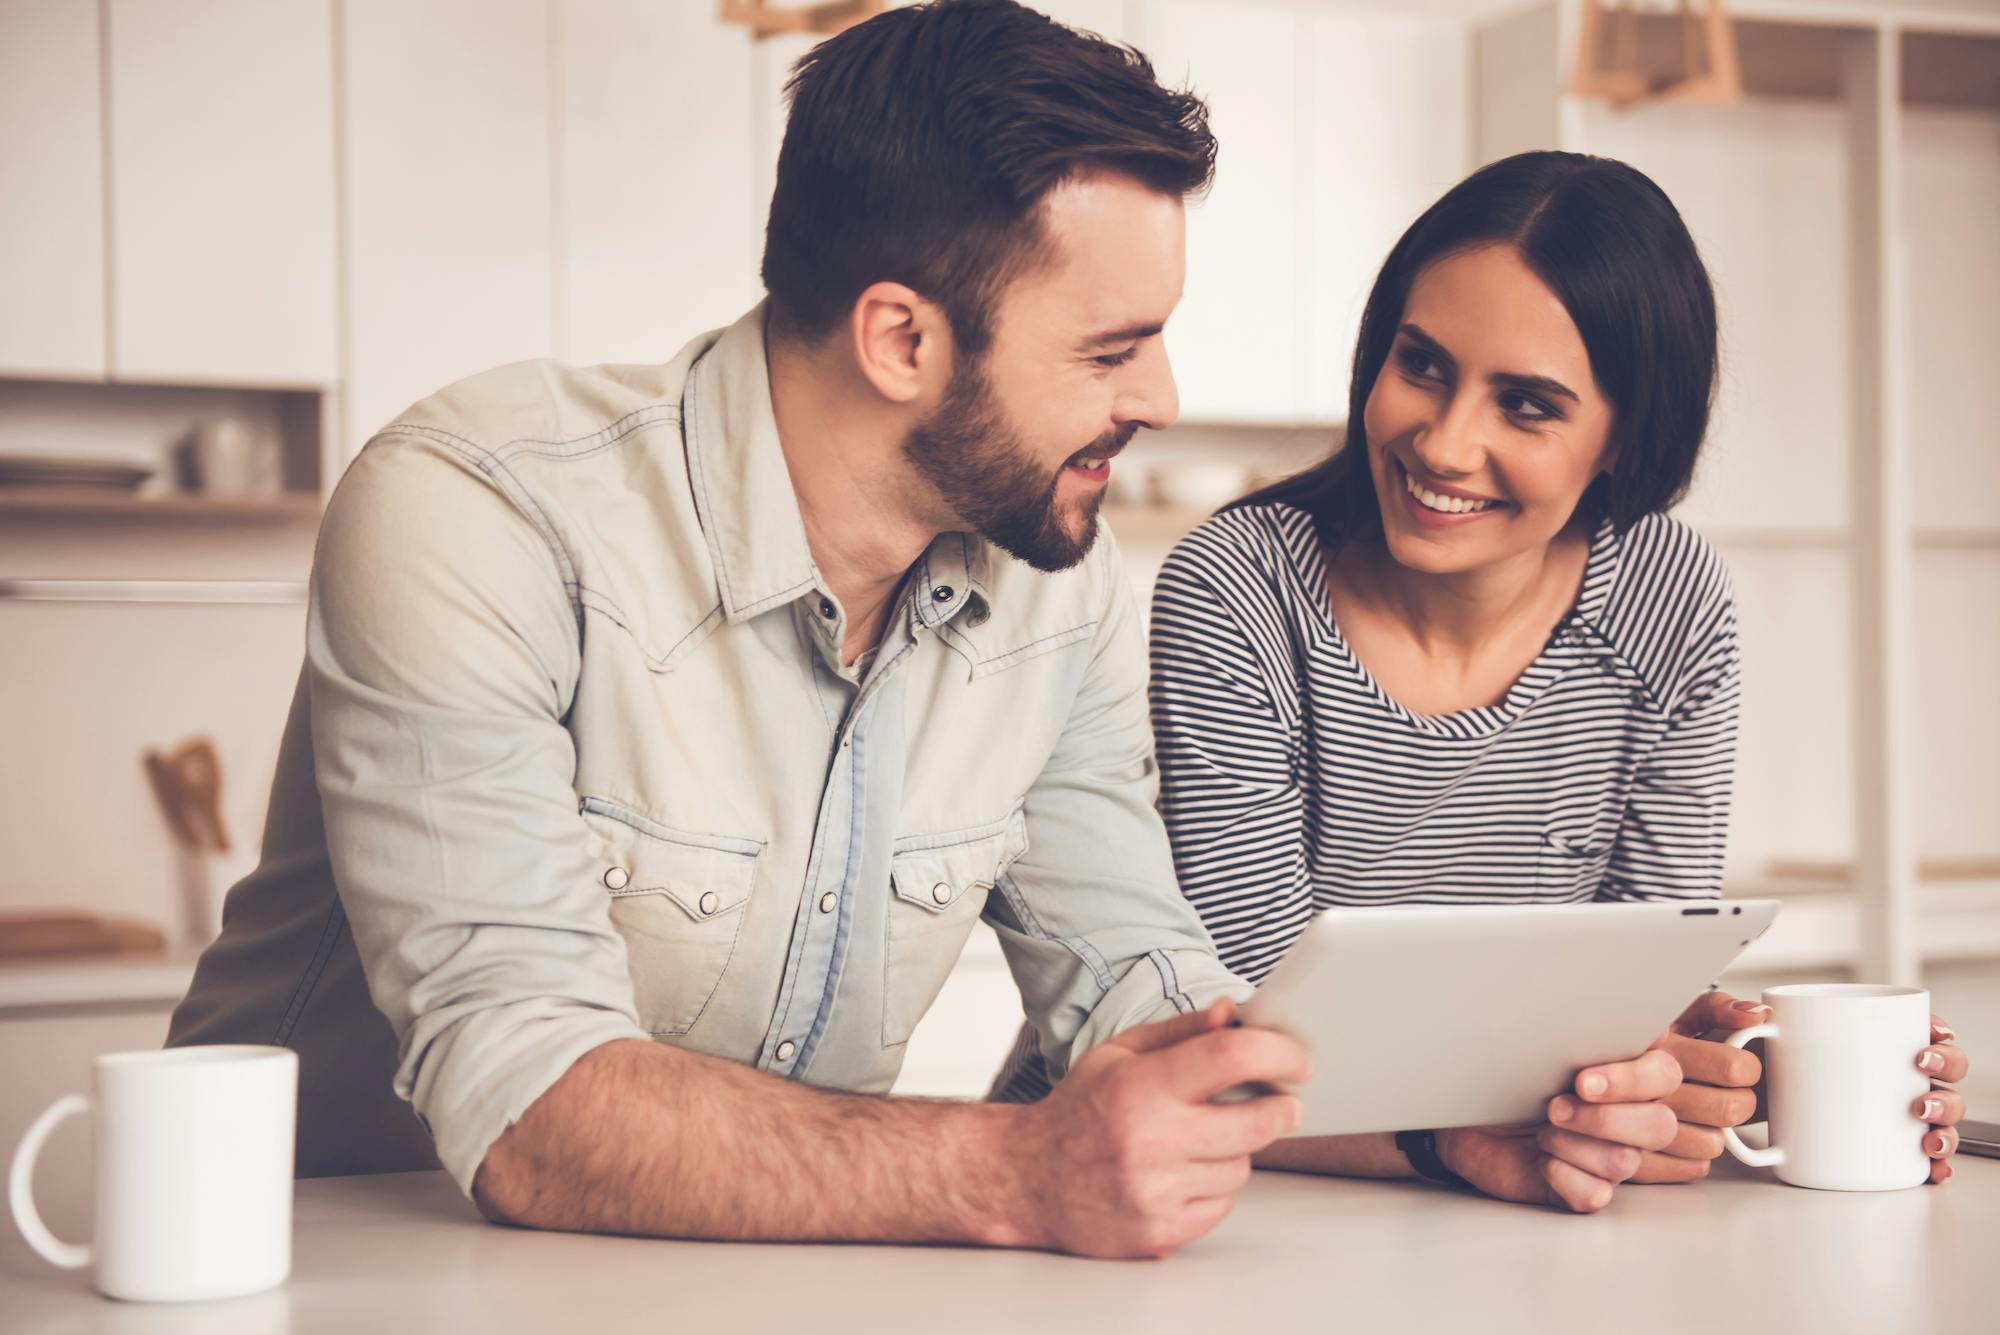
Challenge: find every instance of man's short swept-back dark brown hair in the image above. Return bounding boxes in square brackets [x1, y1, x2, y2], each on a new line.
[764, 0, 1216, 360]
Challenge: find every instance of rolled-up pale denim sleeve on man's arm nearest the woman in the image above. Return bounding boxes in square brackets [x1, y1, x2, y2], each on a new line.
[986, 536, 1254, 1077]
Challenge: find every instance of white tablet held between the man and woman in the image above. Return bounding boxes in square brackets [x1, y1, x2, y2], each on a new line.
[1242, 899, 1778, 1135]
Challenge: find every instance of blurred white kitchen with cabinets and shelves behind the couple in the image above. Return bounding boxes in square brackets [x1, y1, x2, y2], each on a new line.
[0, 0, 2000, 1143]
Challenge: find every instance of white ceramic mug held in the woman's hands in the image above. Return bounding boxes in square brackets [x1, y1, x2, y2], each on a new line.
[1722, 983, 1930, 1191]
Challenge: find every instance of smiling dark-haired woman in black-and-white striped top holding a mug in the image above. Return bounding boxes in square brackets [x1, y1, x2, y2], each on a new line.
[1004, 152, 1966, 1209]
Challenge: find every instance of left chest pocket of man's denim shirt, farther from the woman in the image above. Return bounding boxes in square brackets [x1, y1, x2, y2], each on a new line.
[586, 801, 764, 1037]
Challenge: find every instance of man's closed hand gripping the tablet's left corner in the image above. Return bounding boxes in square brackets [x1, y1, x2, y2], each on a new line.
[1018, 1001, 1312, 1257]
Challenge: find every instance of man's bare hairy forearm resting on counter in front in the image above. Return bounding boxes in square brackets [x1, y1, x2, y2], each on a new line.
[474, 1039, 1040, 1245]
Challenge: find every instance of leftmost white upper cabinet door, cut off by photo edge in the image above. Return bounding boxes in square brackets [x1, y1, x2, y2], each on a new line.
[0, 0, 104, 378]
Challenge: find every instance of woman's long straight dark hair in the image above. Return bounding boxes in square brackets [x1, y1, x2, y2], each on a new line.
[1236, 152, 1716, 546]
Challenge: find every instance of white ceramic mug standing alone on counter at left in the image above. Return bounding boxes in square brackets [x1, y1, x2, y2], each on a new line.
[8, 1045, 298, 1303]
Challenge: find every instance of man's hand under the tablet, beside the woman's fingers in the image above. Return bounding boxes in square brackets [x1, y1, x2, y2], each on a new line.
[1438, 1049, 1680, 1215]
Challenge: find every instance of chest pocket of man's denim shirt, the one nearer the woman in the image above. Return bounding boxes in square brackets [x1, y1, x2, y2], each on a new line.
[882, 811, 1028, 1047]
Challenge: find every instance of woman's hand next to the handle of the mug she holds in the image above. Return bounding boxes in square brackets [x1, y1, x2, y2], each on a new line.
[1632, 991, 1770, 1183]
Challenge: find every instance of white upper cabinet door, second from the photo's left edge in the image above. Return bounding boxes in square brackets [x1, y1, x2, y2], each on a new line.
[106, 0, 340, 384]
